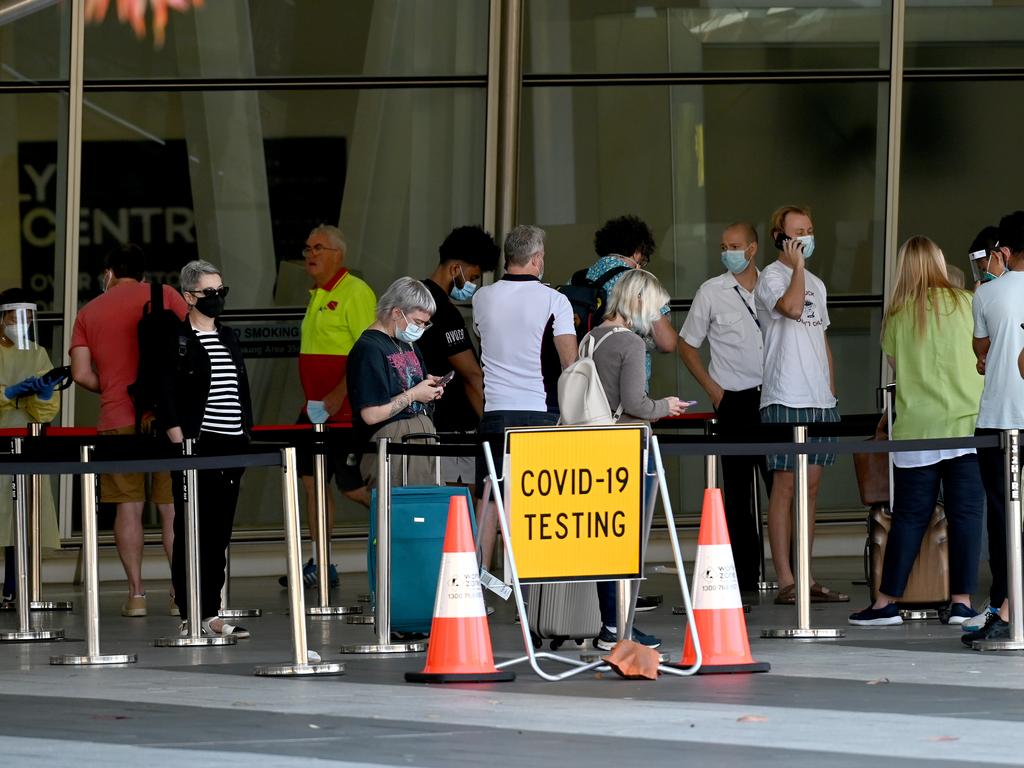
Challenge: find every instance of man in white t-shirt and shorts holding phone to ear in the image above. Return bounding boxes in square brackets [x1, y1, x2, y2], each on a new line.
[754, 206, 850, 604]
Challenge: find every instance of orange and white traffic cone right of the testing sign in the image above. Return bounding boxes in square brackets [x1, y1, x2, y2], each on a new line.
[679, 488, 771, 675]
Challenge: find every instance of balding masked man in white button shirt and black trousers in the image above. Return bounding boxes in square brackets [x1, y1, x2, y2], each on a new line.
[679, 222, 771, 592]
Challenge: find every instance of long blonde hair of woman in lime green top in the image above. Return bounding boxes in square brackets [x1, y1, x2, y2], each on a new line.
[882, 234, 968, 336]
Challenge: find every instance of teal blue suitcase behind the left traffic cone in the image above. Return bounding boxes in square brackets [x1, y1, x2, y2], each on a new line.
[367, 485, 476, 634]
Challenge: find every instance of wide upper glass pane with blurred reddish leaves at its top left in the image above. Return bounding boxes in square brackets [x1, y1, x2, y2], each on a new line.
[85, 0, 488, 81]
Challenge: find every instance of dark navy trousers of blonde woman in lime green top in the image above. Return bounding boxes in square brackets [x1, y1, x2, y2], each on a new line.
[879, 454, 983, 604]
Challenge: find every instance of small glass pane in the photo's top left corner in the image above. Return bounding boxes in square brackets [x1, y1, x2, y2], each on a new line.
[0, 0, 70, 81]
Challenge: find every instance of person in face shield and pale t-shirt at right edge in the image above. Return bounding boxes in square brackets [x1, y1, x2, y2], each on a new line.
[962, 211, 1024, 645]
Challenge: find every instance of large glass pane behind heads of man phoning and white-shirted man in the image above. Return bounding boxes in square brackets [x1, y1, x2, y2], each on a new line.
[519, 83, 886, 298]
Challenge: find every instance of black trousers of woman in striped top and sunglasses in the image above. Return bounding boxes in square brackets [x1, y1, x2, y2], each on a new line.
[171, 432, 249, 618]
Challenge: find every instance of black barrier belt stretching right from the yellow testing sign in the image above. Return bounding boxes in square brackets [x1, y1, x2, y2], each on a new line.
[658, 434, 999, 456]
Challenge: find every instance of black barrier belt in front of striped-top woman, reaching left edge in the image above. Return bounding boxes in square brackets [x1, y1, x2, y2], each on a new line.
[0, 451, 282, 475]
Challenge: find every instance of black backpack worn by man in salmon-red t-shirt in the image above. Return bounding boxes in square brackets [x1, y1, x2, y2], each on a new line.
[128, 283, 181, 432]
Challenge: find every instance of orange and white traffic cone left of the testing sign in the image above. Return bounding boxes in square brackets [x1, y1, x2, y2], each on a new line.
[406, 496, 515, 683]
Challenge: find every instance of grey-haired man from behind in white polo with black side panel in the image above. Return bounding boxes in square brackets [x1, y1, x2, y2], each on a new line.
[473, 224, 577, 567]
